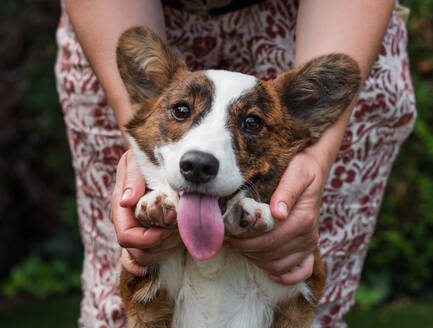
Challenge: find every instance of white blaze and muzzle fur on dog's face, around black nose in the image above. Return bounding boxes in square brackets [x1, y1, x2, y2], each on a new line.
[157, 70, 257, 195]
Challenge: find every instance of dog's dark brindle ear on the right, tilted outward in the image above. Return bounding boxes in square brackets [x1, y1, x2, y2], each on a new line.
[274, 54, 361, 139]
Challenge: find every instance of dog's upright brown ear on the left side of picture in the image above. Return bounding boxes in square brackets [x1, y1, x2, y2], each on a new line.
[117, 27, 187, 104]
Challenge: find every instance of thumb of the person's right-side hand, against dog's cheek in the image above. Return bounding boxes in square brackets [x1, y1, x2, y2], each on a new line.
[270, 162, 314, 220]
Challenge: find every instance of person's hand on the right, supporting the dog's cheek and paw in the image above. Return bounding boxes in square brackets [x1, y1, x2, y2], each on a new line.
[229, 149, 329, 285]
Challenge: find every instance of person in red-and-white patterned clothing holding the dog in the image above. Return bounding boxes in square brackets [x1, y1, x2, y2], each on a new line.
[56, 0, 415, 327]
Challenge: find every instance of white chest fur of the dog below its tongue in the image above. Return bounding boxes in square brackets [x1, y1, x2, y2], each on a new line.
[160, 247, 310, 328]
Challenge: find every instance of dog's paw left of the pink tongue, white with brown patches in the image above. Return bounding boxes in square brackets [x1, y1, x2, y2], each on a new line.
[135, 190, 177, 228]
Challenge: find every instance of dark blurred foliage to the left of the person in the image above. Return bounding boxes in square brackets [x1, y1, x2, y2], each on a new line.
[0, 0, 83, 298]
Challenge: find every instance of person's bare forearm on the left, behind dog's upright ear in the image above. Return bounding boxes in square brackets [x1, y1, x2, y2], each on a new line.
[65, 0, 165, 144]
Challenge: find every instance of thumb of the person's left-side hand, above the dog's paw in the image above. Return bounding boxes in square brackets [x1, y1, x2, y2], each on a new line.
[116, 150, 146, 207]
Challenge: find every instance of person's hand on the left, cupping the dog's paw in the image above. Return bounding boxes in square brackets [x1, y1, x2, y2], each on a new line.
[111, 150, 181, 276]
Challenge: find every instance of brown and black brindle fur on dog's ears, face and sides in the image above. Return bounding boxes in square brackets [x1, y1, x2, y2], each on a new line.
[117, 27, 360, 328]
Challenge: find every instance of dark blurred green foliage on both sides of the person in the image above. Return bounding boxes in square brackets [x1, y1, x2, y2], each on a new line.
[0, 0, 433, 308]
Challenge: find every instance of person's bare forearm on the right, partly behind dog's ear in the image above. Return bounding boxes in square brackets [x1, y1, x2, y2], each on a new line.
[295, 0, 395, 171]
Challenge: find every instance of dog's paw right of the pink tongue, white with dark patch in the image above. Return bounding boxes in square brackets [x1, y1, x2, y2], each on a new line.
[225, 198, 275, 237]
